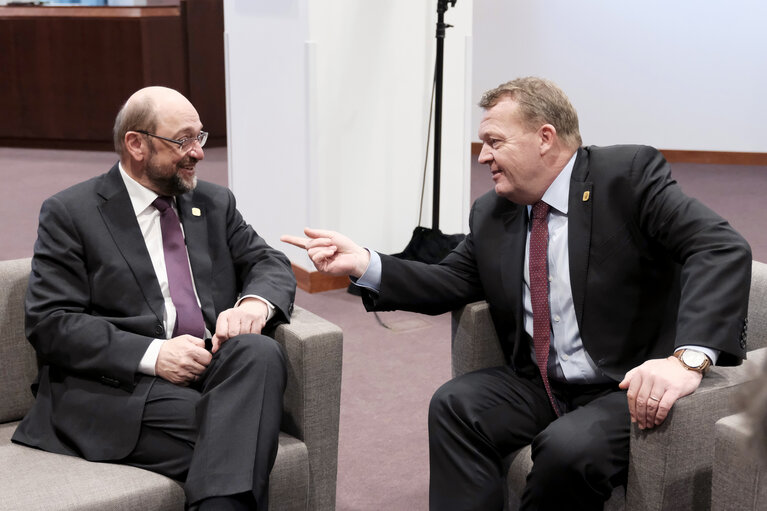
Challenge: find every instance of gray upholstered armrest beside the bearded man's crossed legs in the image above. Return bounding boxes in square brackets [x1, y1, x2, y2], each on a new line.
[274, 307, 343, 509]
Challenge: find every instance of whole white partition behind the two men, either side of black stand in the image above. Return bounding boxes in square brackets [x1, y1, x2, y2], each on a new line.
[224, 0, 472, 268]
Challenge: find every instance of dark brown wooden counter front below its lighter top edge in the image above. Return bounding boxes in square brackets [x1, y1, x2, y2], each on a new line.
[0, 18, 186, 141]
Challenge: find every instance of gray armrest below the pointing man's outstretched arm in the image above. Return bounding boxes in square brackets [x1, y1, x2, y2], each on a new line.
[451, 301, 506, 378]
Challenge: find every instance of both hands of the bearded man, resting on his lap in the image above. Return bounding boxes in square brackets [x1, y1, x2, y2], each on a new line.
[155, 298, 269, 386]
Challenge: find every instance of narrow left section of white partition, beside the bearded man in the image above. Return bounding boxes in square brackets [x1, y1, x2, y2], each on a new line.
[224, 0, 311, 266]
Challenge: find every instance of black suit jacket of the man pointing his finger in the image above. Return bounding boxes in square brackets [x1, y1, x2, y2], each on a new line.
[363, 146, 751, 380]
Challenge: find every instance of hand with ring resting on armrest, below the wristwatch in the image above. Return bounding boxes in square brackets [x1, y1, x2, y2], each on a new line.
[619, 357, 703, 429]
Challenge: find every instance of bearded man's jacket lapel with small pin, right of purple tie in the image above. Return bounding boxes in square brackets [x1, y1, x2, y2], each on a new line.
[176, 192, 216, 332]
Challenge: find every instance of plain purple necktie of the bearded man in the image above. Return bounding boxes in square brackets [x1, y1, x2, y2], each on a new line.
[152, 197, 205, 339]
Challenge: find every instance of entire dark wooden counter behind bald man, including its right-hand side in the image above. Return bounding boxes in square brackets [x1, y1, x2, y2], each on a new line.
[0, 5, 226, 149]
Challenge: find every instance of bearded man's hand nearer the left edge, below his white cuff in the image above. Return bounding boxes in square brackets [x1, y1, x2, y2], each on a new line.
[154, 335, 213, 387]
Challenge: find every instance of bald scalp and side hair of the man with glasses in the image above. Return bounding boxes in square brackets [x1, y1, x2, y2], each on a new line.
[113, 86, 194, 157]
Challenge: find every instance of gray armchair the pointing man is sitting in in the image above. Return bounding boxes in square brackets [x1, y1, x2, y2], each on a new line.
[452, 261, 767, 511]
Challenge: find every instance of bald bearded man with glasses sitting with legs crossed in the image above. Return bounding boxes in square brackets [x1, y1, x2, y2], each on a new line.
[13, 87, 295, 510]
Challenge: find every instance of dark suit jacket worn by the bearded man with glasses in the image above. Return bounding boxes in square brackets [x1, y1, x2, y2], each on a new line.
[13, 165, 295, 460]
